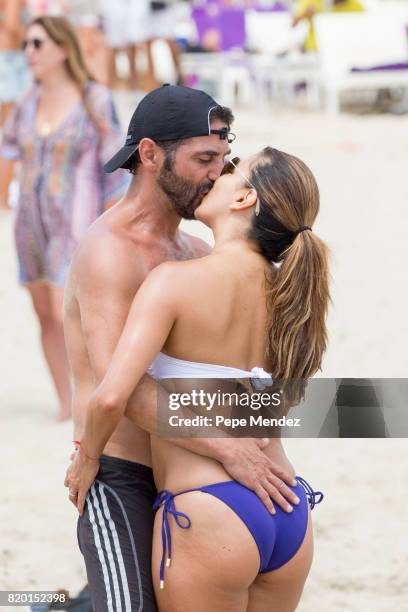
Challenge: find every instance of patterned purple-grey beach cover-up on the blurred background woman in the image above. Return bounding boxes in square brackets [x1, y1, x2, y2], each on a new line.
[0, 82, 130, 286]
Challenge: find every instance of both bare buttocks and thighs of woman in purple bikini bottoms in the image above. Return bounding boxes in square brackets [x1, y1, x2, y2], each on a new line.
[152, 492, 313, 612]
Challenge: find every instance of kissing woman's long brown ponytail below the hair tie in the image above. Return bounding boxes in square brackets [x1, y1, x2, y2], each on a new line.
[267, 231, 330, 380]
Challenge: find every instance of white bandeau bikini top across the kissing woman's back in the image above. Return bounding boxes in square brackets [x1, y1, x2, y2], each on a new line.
[147, 353, 273, 390]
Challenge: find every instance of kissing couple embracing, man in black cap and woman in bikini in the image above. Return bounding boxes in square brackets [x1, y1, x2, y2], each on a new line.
[64, 85, 329, 612]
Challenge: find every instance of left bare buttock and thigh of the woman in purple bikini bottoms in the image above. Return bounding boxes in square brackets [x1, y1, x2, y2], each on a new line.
[153, 492, 259, 612]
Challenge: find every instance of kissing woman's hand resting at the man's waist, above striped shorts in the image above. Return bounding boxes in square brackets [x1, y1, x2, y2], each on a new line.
[64, 447, 99, 516]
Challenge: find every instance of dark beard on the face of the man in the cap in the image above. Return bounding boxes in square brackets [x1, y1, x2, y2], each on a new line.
[157, 161, 213, 219]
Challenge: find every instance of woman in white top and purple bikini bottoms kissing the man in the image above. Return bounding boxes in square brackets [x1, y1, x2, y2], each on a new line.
[81, 148, 329, 612]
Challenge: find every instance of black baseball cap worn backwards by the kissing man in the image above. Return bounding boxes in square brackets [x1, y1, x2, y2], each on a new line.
[104, 84, 235, 172]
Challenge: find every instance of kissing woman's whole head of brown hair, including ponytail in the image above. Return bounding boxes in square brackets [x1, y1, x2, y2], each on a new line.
[250, 147, 330, 380]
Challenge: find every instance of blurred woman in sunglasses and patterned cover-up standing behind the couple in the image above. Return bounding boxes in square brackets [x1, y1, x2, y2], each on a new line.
[1, 17, 128, 420]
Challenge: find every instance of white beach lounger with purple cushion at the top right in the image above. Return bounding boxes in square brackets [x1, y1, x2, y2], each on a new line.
[314, 11, 408, 113]
